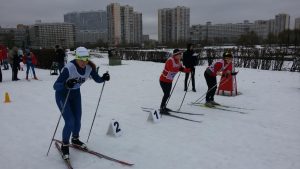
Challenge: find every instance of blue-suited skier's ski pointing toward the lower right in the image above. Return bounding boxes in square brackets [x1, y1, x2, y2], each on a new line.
[54, 139, 134, 166]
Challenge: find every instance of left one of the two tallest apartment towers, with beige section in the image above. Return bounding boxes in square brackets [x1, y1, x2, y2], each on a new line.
[107, 3, 143, 45]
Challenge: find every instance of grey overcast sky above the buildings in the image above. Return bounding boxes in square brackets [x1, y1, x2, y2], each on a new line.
[0, 0, 300, 39]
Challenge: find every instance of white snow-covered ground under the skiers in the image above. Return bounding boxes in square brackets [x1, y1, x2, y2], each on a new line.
[0, 54, 300, 169]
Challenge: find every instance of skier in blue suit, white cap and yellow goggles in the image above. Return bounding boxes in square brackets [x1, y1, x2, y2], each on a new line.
[53, 47, 110, 159]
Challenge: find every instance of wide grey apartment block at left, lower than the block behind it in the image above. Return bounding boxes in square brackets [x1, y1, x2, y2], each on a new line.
[29, 23, 75, 48]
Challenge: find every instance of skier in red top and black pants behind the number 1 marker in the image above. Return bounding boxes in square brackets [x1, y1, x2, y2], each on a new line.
[159, 49, 190, 114]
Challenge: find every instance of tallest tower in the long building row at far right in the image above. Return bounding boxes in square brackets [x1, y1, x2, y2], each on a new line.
[275, 14, 290, 35]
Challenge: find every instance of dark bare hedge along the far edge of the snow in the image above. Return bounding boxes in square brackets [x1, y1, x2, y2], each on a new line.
[113, 47, 300, 71]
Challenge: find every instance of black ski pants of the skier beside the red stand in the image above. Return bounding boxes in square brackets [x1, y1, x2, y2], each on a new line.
[204, 71, 217, 102]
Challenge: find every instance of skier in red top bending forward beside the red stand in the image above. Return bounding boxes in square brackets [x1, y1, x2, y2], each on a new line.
[204, 52, 232, 107]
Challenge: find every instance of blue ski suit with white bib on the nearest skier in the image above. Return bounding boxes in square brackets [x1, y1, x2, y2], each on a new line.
[53, 60, 104, 144]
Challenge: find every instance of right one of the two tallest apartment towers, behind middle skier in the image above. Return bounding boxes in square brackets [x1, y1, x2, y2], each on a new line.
[158, 6, 190, 43]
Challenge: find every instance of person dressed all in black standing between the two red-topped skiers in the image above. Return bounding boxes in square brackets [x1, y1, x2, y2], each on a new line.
[183, 44, 197, 92]
